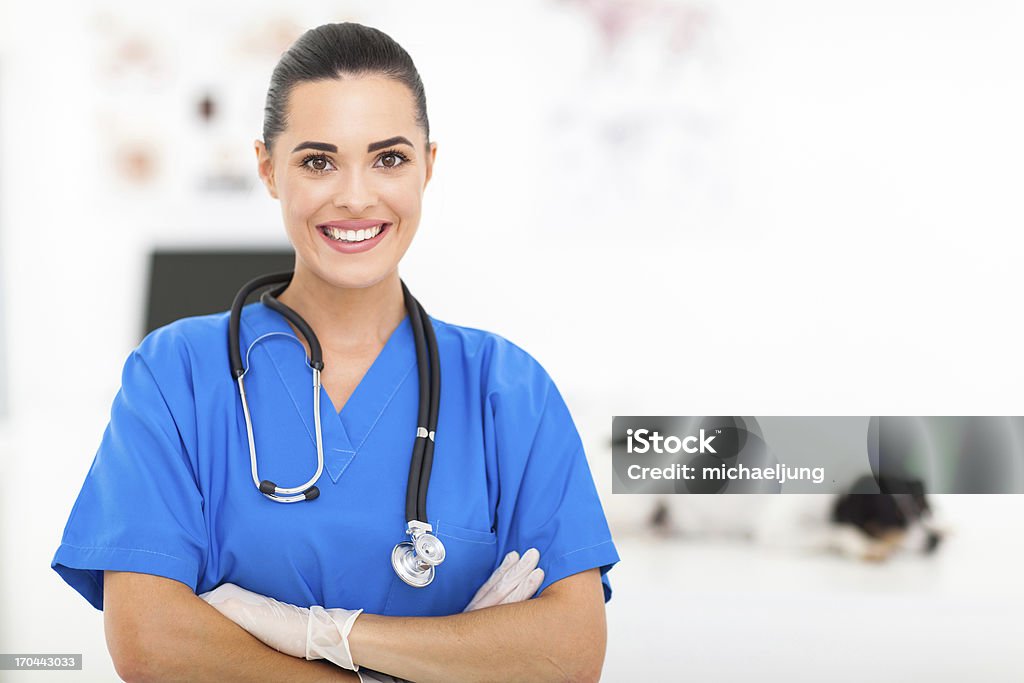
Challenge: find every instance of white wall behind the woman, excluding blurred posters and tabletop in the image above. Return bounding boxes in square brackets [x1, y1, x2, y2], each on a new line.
[0, 0, 1024, 681]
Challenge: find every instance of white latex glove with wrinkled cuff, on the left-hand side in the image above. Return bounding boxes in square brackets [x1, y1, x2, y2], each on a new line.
[199, 584, 362, 671]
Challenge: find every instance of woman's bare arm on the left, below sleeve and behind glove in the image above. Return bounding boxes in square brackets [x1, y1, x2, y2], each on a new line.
[103, 571, 358, 683]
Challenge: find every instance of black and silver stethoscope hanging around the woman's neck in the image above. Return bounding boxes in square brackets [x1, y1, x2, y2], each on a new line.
[227, 270, 444, 588]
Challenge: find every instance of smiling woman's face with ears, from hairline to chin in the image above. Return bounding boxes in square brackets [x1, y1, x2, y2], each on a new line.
[256, 76, 437, 288]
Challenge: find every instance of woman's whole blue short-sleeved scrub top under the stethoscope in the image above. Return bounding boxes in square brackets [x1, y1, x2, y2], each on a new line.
[51, 303, 618, 616]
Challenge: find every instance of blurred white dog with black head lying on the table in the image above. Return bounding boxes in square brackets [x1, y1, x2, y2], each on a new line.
[646, 475, 947, 562]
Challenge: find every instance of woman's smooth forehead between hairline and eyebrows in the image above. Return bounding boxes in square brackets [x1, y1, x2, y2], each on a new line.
[284, 76, 422, 148]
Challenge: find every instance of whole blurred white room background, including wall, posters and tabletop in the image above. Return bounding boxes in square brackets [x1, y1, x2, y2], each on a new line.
[0, 0, 1024, 681]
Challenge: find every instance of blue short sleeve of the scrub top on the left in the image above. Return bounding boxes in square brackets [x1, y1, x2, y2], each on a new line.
[50, 349, 209, 609]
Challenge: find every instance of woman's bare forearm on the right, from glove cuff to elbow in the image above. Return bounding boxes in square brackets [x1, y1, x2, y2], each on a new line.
[348, 568, 607, 683]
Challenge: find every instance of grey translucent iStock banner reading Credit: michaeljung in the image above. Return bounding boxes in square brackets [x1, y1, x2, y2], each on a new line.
[611, 416, 1024, 494]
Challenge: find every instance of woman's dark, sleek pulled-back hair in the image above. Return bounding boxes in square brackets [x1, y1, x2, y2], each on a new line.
[263, 22, 430, 150]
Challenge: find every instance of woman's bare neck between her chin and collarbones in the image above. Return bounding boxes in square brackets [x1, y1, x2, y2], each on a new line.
[278, 268, 406, 353]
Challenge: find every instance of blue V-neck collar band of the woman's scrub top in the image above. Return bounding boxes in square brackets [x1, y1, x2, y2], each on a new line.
[242, 302, 416, 483]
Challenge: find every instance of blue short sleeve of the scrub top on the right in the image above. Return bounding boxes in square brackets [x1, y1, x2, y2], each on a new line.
[488, 348, 618, 602]
